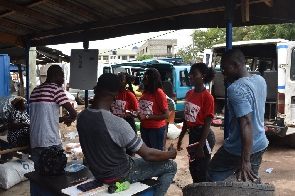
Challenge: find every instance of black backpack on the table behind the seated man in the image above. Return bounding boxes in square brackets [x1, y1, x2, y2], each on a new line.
[38, 147, 67, 176]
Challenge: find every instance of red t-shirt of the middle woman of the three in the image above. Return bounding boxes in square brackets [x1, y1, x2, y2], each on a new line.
[139, 88, 168, 129]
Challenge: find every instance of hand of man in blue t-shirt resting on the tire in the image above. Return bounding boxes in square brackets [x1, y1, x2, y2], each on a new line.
[235, 161, 258, 182]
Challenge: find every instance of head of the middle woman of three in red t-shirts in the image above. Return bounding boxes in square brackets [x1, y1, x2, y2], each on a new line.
[143, 68, 162, 93]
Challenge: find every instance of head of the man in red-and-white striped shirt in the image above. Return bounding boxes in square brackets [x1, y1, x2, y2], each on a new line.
[46, 65, 65, 86]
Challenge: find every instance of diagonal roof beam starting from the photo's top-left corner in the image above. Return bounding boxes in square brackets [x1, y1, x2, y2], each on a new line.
[0, 0, 69, 27]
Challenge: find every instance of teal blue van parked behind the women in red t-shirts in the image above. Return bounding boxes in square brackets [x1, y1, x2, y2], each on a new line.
[112, 60, 192, 122]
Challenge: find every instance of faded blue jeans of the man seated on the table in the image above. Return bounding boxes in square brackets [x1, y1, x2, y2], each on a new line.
[125, 157, 177, 196]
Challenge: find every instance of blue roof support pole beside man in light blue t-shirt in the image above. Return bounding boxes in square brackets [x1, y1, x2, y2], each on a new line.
[224, 0, 236, 139]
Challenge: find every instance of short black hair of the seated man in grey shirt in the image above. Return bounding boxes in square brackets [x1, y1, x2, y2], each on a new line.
[96, 73, 120, 93]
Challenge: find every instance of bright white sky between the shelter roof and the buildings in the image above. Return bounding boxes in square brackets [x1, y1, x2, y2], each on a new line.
[47, 29, 194, 56]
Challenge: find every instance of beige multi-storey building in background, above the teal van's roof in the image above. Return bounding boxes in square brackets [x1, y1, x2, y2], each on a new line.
[137, 39, 177, 59]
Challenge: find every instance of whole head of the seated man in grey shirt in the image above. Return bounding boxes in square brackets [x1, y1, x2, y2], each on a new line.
[94, 73, 120, 101]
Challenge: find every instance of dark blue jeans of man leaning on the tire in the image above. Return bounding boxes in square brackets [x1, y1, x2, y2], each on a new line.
[207, 146, 266, 182]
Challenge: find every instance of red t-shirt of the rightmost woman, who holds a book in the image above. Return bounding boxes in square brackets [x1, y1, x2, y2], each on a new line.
[184, 89, 214, 127]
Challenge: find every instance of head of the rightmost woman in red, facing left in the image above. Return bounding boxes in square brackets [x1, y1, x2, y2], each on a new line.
[189, 63, 215, 86]
